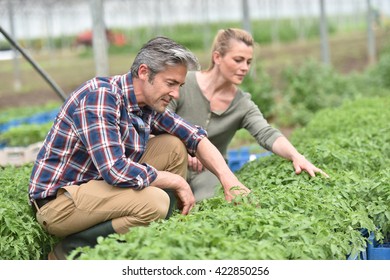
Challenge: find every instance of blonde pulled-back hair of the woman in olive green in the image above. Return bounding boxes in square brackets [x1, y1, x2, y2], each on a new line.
[207, 28, 254, 71]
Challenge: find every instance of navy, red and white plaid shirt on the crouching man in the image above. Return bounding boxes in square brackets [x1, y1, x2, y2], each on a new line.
[29, 73, 206, 199]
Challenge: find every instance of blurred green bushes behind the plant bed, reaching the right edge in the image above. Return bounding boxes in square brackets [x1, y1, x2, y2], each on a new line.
[270, 42, 390, 126]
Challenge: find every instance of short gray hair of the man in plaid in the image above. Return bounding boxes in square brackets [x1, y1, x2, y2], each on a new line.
[130, 36, 200, 81]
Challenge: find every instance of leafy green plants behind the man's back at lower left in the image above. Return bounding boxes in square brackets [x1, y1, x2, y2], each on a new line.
[0, 164, 54, 260]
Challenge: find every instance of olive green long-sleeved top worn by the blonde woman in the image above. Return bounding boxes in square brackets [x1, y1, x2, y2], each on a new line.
[168, 71, 282, 157]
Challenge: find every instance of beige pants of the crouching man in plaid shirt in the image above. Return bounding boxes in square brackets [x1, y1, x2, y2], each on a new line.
[37, 134, 187, 237]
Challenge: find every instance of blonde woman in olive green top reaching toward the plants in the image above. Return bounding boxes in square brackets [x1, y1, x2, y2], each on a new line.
[168, 28, 328, 201]
